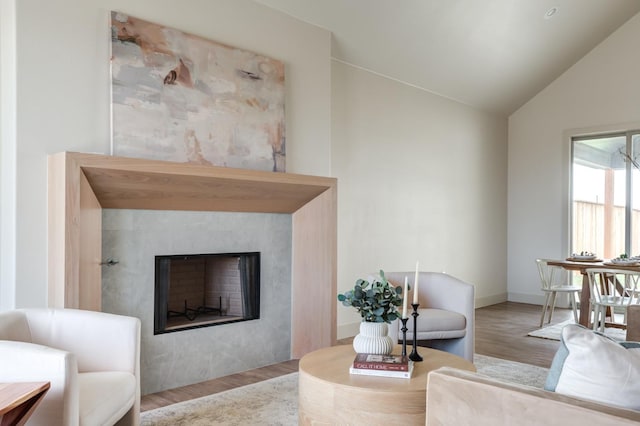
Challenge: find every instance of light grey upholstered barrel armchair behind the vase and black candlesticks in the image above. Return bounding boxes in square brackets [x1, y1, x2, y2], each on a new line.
[385, 271, 475, 362]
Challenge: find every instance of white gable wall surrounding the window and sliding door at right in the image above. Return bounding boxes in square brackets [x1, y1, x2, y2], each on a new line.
[508, 15, 640, 303]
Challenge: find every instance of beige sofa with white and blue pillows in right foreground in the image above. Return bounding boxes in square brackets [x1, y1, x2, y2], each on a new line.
[427, 320, 640, 426]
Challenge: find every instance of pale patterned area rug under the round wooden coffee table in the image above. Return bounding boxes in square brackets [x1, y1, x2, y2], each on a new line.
[141, 354, 548, 426]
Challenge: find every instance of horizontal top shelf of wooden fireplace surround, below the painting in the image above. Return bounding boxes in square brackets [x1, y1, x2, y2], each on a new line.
[62, 153, 336, 213]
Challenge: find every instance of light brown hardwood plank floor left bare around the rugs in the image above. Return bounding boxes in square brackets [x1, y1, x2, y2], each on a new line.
[141, 302, 572, 411]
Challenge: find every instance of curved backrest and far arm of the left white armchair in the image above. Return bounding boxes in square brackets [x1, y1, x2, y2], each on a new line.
[24, 309, 140, 376]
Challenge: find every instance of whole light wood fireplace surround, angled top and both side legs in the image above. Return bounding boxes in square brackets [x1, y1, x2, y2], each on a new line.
[48, 152, 337, 358]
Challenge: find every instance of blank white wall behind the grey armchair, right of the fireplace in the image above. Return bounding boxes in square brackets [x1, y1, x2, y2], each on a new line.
[332, 61, 507, 338]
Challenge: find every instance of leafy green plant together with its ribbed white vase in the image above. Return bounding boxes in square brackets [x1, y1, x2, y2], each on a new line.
[338, 270, 402, 355]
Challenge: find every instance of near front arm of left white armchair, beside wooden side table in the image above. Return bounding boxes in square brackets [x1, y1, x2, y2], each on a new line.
[0, 340, 79, 424]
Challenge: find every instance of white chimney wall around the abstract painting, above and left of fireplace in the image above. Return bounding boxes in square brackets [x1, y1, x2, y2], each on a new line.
[0, 0, 331, 309]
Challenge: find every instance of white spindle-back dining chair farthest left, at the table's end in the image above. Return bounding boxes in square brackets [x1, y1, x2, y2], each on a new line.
[536, 259, 586, 327]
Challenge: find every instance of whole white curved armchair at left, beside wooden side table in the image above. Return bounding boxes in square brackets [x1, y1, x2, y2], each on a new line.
[0, 309, 140, 426]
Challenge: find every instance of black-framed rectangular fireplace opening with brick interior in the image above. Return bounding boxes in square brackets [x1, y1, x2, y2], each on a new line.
[154, 252, 260, 334]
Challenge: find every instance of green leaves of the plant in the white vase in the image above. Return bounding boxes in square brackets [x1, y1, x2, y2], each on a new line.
[338, 270, 402, 323]
